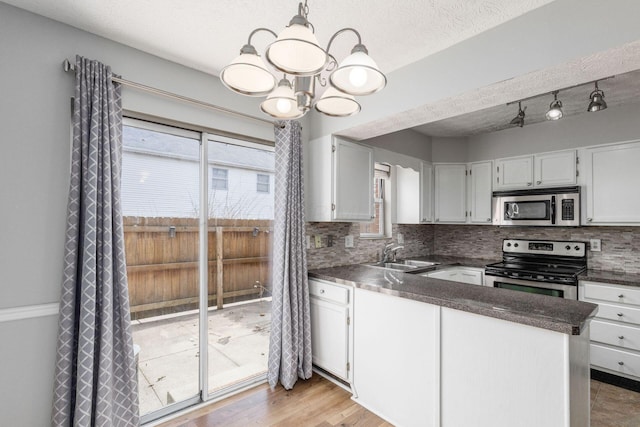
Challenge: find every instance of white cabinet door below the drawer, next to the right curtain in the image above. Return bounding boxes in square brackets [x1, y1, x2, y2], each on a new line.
[309, 298, 349, 380]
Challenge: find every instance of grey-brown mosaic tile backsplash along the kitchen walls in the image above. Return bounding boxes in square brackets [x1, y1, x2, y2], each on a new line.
[306, 223, 640, 274]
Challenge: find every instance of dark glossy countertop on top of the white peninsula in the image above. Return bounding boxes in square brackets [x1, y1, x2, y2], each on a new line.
[309, 262, 598, 335]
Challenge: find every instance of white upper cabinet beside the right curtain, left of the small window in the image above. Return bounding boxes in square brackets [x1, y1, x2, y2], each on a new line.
[304, 136, 374, 222]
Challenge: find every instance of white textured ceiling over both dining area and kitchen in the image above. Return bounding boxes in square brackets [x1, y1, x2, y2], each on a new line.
[2, 0, 640, 139]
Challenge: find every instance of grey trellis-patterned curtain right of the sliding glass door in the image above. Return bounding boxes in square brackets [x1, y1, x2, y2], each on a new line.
[267, 121, 311, 390]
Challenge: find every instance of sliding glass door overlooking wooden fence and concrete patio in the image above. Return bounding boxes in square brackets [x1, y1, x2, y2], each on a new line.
[122, 119, 274, 422]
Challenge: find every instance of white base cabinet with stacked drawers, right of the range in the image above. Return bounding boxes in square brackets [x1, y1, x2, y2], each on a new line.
[578, 281, 640, 381]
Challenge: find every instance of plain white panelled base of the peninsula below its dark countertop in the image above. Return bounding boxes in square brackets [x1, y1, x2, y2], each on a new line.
[352, 288, 589, 427]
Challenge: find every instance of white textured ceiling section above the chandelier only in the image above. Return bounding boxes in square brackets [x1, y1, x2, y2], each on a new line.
[2, 0, 552, 75]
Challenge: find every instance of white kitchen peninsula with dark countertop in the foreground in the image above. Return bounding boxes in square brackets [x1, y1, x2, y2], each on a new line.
[309, 265, 597, 427]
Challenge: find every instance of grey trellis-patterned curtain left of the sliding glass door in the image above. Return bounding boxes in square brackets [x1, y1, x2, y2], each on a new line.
[52, 56, 140, 427]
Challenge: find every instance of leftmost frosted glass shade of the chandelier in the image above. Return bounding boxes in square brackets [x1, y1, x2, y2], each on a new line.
[220, 44, 276, 96]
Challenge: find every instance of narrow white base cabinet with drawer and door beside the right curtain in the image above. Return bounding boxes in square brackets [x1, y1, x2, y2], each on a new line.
[309, 278, 352, 382]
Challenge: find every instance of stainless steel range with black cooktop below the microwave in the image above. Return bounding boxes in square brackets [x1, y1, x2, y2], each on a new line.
[484, 239, 587, 300]
